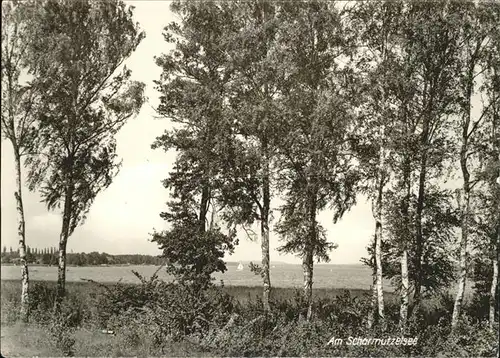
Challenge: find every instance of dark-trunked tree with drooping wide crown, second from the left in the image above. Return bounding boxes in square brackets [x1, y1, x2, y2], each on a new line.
[27, 0, 144, 310]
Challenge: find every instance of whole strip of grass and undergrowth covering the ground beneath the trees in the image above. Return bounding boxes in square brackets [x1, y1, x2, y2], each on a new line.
[1, 280, 498, 357]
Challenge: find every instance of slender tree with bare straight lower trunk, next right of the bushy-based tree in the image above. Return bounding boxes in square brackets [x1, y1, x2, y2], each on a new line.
[226, 0, 283, 310]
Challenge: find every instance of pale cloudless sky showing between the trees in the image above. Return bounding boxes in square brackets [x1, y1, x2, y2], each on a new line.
[1, 0, 375, 264]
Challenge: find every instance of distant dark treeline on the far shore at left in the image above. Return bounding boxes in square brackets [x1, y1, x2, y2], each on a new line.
[1, 246, 162, 266]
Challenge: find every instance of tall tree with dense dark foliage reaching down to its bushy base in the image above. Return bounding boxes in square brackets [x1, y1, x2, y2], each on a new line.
[153, 1, 240, 289]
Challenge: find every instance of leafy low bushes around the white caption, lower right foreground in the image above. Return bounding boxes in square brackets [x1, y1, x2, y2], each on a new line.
[200, 293, 498, 357]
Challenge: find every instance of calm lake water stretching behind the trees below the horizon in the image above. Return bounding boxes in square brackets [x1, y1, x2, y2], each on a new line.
[1, 264, 393, 291]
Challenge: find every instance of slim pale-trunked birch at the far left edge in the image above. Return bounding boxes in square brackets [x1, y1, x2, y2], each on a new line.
[1, 1, 37, 321]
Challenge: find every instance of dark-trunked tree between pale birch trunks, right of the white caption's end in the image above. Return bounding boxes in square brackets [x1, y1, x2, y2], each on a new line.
[405, 2, 458, 307]
